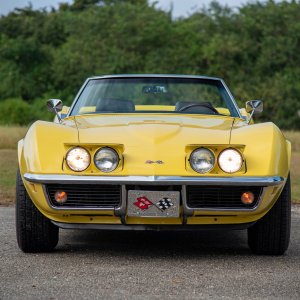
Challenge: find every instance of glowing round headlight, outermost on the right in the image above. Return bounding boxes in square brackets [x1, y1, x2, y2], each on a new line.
[218, 149, 243, 173]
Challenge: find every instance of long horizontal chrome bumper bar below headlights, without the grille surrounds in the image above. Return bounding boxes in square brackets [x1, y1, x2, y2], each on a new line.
[23, 173, 284, 186]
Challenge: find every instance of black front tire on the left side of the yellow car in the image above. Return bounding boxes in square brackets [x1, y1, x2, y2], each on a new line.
[16, 170, 59, 252]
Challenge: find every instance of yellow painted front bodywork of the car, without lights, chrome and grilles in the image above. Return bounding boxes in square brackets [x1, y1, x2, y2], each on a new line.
[18, 112, 291, 224]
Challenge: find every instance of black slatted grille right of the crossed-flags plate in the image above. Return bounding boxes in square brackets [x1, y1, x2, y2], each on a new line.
[186, 185, 262, 209]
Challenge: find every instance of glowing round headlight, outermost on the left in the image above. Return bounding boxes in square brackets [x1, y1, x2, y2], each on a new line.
[66, 147, 91, 172]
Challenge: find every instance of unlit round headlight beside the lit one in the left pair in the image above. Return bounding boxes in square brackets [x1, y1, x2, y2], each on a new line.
[94, 148, 120, 173]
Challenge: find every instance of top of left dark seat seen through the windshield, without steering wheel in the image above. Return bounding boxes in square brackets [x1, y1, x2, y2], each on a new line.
[96, 98, 135, 113]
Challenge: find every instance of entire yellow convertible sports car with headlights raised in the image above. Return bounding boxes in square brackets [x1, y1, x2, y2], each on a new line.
[16, 75, 291, 255]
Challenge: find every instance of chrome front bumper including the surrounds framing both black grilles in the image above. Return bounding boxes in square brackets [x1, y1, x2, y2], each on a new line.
[23, 173, 284, 218]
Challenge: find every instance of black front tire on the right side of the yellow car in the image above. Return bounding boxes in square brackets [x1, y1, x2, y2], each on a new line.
[248, 176, 291, 255]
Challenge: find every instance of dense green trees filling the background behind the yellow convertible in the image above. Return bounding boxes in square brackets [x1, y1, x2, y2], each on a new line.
[0, 0, 300, 129]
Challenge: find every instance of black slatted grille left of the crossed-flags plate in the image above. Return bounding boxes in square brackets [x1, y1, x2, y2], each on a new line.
[46, 184, 121, 208]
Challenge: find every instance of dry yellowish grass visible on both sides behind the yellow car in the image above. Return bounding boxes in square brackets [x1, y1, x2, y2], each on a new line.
[0, 126, 300, 205]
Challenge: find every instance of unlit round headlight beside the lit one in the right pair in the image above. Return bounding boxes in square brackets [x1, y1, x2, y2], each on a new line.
[190, 148, 215, 173]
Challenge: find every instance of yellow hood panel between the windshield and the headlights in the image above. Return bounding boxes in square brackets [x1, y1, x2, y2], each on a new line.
[75, 114, 234, 145]
